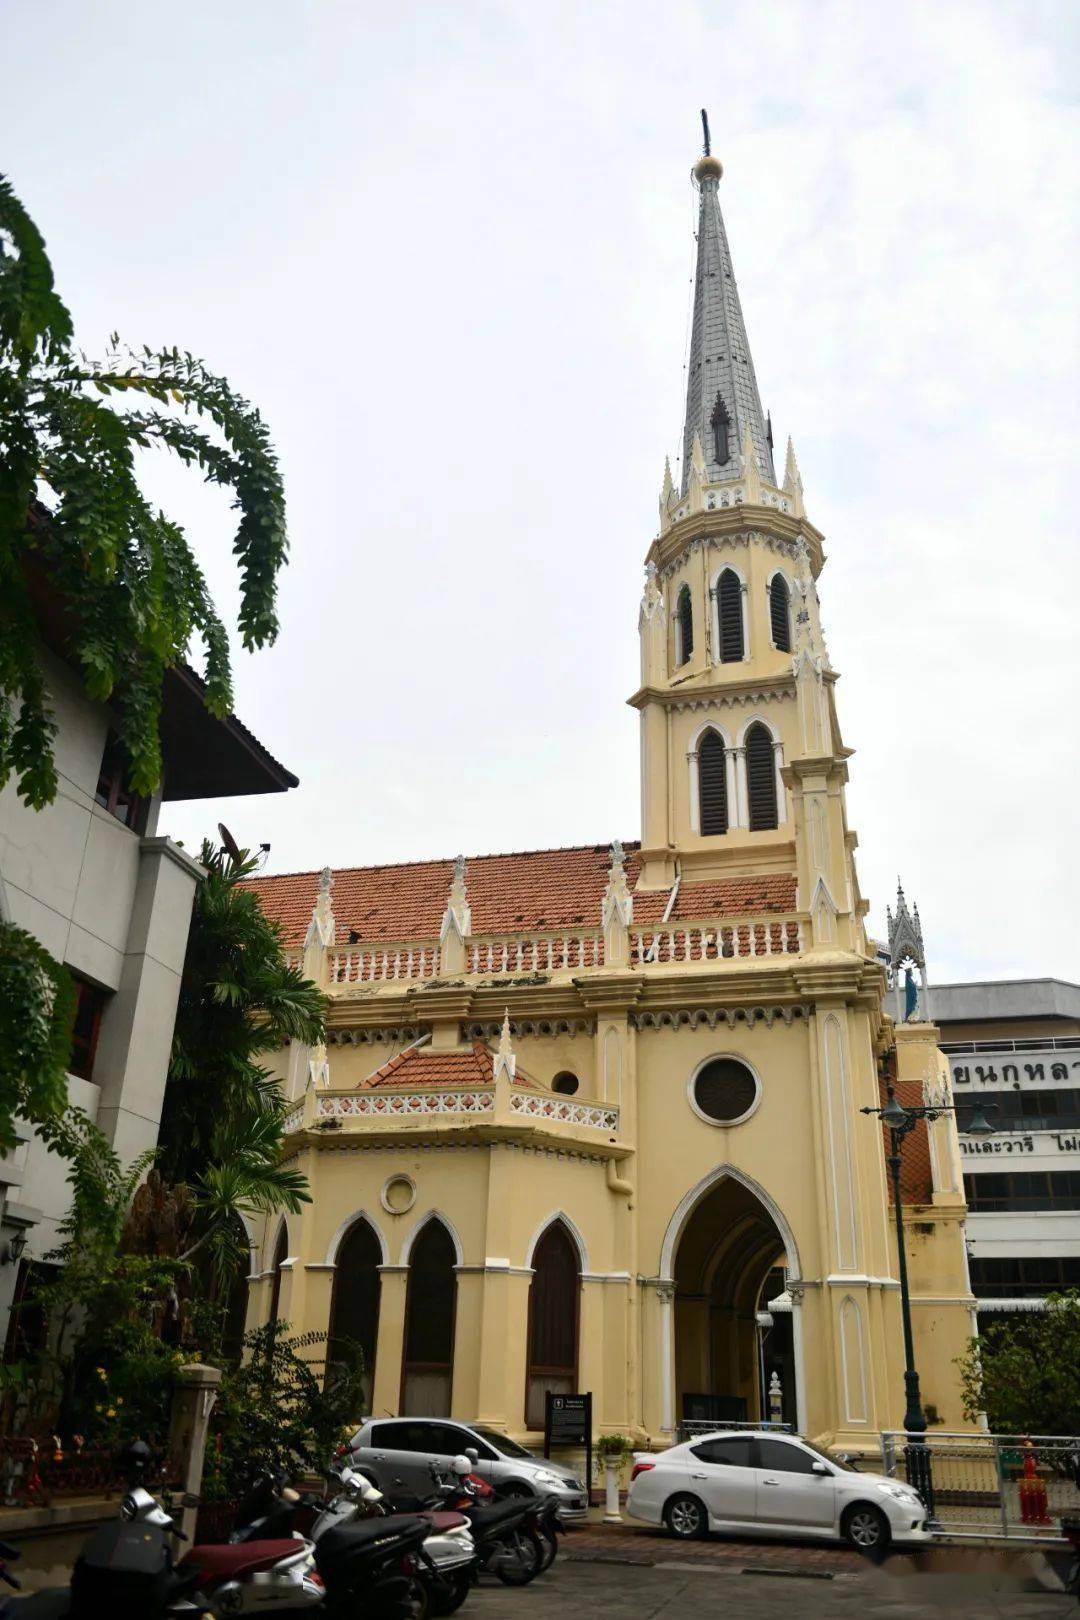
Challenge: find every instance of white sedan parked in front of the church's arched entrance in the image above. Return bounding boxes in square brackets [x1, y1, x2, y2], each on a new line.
[627, 1429, 929, 1552]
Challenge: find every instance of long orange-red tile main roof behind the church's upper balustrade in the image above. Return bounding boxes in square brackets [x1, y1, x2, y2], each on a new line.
[251, 844, 795, 946]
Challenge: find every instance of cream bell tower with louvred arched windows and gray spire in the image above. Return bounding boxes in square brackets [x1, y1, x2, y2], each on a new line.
[630, 136, 866, 954]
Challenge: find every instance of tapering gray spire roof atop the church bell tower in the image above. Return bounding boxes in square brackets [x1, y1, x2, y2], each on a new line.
[682, 154, 776, 494]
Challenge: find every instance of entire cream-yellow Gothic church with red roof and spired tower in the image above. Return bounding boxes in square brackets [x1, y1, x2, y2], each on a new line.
[249, 157, 973, 1450]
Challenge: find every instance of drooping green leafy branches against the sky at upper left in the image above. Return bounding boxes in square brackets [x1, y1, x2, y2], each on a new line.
[0, 175, 287, 808]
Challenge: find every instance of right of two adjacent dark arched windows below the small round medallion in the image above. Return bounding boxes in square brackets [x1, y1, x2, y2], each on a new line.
[402, 1220, 458, 1418]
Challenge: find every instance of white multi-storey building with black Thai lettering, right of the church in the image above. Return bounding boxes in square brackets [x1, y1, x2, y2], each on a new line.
[933, 978, 1080, 1322]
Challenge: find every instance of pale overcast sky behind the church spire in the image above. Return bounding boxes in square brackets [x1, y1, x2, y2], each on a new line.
[8, 0, 1080, 980]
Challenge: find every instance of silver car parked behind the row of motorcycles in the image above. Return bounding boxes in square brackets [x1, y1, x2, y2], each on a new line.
[348, 1418, 589, 1523]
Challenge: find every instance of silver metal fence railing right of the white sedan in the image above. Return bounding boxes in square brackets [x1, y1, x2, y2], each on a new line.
[881, 1429, 1080, 1541]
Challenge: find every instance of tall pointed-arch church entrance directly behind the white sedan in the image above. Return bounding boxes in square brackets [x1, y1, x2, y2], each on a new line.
[672, 1175, 797, 1422]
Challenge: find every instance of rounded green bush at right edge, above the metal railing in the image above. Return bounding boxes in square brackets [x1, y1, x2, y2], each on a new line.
[957, 1290, 1080, 1435]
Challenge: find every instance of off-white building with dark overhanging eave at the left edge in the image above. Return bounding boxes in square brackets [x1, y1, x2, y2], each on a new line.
[0, 631, 296, 1358]
